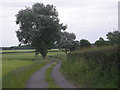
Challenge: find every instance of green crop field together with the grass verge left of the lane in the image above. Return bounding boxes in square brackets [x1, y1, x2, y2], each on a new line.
[2, 50, 64, 88]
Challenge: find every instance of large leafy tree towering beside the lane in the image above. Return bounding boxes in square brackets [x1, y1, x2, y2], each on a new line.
[16, 3, 66, 58]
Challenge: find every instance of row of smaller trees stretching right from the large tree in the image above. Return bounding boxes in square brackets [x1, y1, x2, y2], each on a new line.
[53, 30, 120, 54]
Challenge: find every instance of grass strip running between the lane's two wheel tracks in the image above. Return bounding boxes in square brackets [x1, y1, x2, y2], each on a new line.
[45, 59, 60, 88]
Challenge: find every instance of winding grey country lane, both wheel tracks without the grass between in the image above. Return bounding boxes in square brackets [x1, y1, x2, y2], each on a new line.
[26, 58, 77, 90]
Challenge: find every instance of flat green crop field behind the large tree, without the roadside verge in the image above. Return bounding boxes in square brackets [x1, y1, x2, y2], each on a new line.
[2, 50, 64, 77]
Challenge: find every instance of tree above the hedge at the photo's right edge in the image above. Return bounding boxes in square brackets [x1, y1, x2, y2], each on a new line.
[106, 31, 120, 45]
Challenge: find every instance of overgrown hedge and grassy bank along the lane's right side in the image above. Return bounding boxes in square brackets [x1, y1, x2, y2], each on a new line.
[60, 45, 118, 88]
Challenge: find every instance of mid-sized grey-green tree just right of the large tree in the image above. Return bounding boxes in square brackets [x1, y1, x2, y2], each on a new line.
[57, 32, 76, 54]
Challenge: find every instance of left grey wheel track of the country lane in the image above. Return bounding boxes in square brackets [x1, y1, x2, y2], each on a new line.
[26, 62, 52, 88]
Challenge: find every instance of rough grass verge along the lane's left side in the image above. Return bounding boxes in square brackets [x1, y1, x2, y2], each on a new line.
[2, 60, 46, 88]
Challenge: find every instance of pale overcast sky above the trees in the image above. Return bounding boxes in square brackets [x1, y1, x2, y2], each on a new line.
[0, 0, 119, 46]
